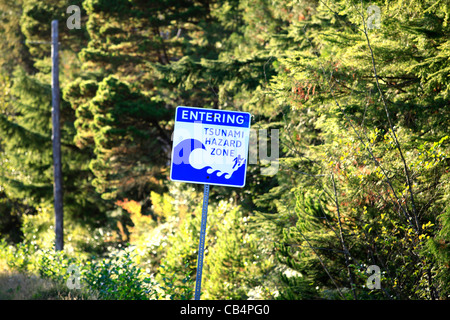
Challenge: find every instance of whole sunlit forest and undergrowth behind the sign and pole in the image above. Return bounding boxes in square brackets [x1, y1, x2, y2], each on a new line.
[0, 0, 450, 300]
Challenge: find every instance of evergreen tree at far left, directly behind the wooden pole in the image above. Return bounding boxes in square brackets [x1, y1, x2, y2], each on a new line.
[0, 1, 105, 242]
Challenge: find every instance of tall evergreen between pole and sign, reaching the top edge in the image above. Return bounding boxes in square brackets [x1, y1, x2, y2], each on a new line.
[65, 0, 213, 199]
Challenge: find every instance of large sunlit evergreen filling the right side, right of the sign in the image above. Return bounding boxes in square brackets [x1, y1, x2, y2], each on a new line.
[264, 1, 448, 299]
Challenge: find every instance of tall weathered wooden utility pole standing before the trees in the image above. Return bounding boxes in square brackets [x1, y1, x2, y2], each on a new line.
[52, 20, 64, 251]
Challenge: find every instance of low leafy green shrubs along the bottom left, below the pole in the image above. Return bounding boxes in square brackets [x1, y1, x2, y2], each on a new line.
[0, 241, 194, 300]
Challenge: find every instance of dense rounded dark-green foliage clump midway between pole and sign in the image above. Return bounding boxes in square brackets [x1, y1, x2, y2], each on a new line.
[76, 76, 167, 199]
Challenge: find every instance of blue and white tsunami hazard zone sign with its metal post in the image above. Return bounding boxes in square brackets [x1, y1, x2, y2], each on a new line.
[170, 106, 251, 300]
